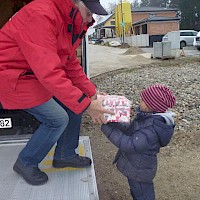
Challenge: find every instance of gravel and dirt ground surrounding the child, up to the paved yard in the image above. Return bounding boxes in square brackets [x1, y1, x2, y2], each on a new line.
[81, 58, 200, 200]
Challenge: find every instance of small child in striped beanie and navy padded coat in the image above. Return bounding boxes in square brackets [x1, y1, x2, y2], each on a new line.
[101, 84, 176, 200]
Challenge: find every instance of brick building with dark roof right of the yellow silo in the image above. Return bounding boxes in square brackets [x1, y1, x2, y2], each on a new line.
[132, 7, 180, 46]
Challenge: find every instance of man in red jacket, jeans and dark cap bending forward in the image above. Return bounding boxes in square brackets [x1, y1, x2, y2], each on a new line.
[0, 0, 110, 185]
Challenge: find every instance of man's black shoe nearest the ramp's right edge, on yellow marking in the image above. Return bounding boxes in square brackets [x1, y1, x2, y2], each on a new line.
[53, 155, 92, 168]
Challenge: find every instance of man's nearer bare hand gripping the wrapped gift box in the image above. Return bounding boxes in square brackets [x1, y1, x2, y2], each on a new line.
[87, 98, 115, 124]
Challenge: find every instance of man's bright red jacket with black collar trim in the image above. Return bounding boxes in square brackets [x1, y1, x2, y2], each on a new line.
[0, 0, 96, 114]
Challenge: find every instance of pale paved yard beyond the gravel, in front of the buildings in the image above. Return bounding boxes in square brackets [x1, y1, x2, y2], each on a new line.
[88, 44, 200, 77]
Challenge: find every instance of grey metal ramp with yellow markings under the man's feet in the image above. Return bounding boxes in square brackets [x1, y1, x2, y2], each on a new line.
[0, 136, 99, 200]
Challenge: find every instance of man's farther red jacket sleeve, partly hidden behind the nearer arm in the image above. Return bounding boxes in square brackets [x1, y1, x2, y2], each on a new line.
[64, 54, 96, 97]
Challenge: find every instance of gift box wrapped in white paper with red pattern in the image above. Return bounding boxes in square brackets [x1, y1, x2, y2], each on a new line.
[98, 95, 132, 122]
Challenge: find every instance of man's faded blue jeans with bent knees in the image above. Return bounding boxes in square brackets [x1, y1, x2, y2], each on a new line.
[19, 98, 82, 167]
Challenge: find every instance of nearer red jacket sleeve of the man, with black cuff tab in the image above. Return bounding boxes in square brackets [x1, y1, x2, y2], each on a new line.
[13, 12, 94, 114]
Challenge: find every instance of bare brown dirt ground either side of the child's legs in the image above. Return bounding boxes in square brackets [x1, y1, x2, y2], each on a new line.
[81, 44, 200, 200]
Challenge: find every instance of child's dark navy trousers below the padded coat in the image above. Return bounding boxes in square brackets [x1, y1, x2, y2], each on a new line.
[128, 179, 155, 200]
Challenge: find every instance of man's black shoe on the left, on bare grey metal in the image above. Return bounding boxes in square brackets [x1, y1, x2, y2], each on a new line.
[13, 159, 48, 185]
